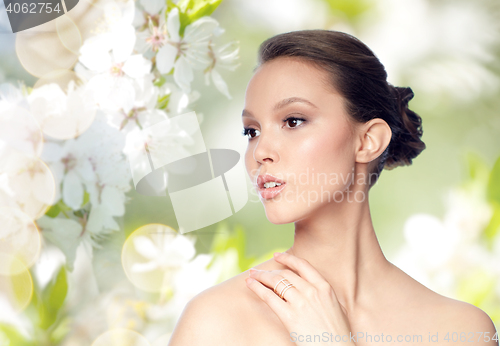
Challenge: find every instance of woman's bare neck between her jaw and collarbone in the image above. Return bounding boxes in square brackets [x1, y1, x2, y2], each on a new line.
[286, 191, 392, 313]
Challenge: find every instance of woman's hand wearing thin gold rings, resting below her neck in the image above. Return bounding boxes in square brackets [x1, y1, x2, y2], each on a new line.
[246, 252, 355, 346]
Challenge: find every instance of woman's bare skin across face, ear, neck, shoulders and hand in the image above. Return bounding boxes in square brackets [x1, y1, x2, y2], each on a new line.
[169, 57, 498, 346]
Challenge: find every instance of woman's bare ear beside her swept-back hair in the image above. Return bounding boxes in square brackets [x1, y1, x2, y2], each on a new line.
[356, 118, 392, 163]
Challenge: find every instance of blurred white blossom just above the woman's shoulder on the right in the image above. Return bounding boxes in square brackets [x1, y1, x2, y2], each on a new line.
[394, 184, 496, 296]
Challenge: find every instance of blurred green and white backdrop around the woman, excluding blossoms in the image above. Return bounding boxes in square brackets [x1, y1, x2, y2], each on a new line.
[121, 0, 500, 259]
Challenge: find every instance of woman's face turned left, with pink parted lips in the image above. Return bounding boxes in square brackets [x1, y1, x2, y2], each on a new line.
[242, 58, 359, 224]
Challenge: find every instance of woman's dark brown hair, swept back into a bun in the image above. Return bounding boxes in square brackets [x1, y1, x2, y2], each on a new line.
[257, 30, 425, 186]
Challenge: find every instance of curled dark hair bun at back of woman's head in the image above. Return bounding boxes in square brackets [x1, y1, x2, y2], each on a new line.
[384, 84, 425, 170]
